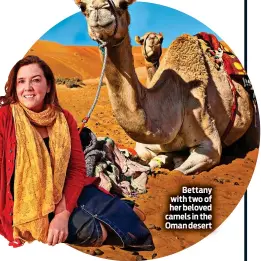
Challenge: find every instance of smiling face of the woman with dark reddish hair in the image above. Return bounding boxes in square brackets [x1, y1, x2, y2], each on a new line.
[16, 63, 50, 112]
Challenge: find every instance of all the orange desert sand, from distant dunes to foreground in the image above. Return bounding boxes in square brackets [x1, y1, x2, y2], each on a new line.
[26, 41, 258, 261]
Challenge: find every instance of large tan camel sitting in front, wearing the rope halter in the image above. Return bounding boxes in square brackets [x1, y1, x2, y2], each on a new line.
[75, 0, 253, 175]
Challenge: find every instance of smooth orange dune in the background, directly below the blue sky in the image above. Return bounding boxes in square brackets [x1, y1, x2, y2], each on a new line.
[26, 40, 158, 79]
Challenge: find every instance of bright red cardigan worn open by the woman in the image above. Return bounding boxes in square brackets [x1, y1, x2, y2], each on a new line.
[0, 105, 97, 241]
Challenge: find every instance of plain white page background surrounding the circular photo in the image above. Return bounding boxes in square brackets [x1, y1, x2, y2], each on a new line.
[0, 0, 261, 261]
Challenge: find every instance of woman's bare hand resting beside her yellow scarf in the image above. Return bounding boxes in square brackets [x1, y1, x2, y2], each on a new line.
[47, 210, 70, 246]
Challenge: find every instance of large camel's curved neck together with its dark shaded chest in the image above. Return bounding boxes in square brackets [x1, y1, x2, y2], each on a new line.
[98, 33, 188, 144]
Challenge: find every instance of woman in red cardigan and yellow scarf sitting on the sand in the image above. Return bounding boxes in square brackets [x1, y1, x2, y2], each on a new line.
[0, 56, 154, 250]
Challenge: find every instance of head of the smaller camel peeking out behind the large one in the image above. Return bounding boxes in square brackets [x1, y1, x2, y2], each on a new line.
[135, 32, 163, 62]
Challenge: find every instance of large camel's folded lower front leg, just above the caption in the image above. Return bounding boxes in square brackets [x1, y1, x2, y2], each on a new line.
[175, 140, 221, 175]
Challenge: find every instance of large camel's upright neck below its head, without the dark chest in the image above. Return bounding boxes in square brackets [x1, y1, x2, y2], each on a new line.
[101, 35, 145, 133]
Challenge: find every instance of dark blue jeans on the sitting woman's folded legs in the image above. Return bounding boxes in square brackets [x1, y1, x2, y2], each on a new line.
[65, 185, 155, 250]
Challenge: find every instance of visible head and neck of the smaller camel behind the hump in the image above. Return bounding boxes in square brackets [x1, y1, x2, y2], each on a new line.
[135, 32, 163, 86]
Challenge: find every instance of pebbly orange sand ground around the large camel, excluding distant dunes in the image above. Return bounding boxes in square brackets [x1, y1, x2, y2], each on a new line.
[58, 82, 258, 261]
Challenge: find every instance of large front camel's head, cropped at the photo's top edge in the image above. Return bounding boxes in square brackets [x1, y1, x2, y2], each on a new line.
[75, 0, 135, 43]
